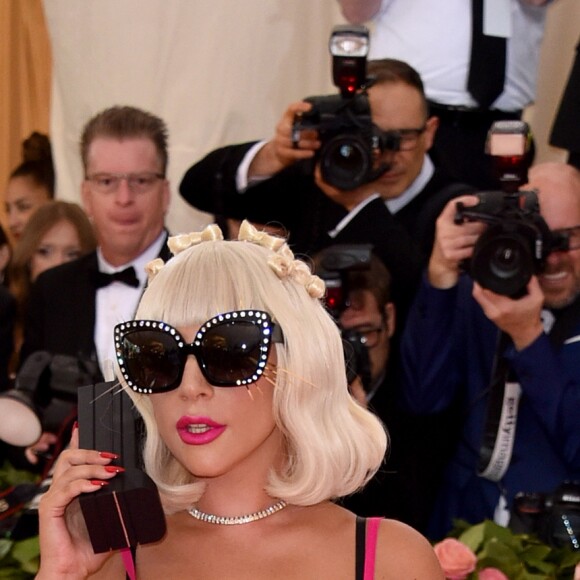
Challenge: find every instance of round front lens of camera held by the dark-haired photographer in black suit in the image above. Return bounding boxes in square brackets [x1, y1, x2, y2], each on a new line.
[320, 135, 372, 190]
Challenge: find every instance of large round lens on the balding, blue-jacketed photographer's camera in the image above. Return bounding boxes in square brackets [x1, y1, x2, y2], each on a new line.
[471, 224, 534, 297]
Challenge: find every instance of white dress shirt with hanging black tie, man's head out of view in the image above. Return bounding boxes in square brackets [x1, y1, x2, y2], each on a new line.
[369, 0, 546, 111]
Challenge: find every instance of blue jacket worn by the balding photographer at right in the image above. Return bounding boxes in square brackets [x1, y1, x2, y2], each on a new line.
[401, 275, 580, 540]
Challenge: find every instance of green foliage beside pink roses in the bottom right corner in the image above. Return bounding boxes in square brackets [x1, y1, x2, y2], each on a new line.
[449, 520, 580, 580]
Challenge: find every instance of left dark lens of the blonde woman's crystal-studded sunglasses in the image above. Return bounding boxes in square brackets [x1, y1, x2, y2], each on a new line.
[121, 330, 180, 391]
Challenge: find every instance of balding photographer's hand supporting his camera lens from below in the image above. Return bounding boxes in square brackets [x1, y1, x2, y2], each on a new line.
[473, 276, 544, 350]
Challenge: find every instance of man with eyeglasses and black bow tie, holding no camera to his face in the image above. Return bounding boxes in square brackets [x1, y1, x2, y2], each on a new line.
[15, 106, 170, 472]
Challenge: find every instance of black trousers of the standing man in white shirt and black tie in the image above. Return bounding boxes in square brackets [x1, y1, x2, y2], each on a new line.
[429, 102, 534, 190]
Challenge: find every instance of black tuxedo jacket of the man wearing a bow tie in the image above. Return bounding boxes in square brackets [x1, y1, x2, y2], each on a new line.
[20, 233, 171, 380]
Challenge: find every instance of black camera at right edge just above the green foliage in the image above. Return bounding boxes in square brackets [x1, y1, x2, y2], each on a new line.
[509, 481, 580, 550]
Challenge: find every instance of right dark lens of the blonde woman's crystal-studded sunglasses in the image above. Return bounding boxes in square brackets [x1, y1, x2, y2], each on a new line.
[199, 320, 262, 385]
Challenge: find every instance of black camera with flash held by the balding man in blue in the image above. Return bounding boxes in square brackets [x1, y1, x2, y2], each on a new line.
[455, 121, 567, 298]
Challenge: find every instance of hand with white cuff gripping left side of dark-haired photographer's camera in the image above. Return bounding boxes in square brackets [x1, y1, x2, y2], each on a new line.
[248, 101, 320, 177]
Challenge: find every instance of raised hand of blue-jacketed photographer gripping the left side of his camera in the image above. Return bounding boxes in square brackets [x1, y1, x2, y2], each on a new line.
[428, 195, 485, 289]
